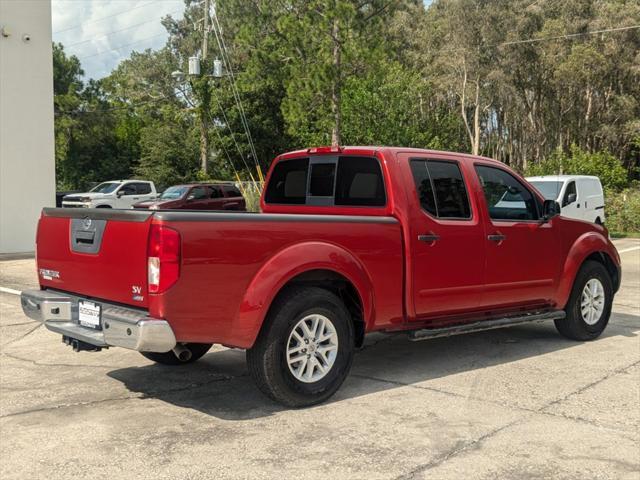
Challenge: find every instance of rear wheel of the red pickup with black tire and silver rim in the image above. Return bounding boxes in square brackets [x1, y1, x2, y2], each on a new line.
[247, 287, 354, 407]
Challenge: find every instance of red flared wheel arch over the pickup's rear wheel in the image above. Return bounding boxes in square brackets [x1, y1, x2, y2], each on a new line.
[232, 242, 374, 348]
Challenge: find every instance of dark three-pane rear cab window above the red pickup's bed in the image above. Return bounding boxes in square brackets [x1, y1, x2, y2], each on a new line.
[265, 155, 387, 207]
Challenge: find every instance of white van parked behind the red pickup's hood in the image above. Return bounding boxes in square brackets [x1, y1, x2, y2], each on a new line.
[527, 175, 604, 224]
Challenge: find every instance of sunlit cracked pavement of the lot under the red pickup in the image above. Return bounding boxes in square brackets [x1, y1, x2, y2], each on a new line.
[0, 239, 640, 480]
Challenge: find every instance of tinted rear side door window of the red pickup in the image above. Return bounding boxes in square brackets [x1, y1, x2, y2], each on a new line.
[411, 160, 471, 220]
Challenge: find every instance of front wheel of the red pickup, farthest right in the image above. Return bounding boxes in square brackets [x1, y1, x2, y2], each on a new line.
[555, 260, 613, 341]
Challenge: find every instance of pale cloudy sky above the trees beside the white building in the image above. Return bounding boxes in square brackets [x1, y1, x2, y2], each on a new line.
[51, 0, 184, 78]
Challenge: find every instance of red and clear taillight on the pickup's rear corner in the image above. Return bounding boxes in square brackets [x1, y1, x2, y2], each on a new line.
[147, 224, 180, 293]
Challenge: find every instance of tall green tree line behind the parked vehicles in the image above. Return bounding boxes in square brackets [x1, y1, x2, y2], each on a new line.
[54, 0, 640, 190]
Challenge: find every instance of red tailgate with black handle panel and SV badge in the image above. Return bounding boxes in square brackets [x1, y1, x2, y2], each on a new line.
[36, 208, 153, 308]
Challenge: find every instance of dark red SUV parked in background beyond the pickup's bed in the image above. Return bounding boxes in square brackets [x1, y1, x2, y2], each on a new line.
[133, 183, 246, 210]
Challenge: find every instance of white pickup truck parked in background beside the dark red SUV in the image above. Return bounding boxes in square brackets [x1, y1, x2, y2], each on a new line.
[62, 180, 158, 208]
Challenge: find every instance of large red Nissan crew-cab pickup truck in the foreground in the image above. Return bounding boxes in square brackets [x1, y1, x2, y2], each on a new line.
[22, 147, 620, 406]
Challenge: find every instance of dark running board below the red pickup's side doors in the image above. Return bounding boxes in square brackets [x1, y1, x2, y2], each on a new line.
[409, 310, 566, 342]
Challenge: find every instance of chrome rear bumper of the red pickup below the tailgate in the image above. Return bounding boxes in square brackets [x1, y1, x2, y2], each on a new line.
[20, 290, 176, 352]
